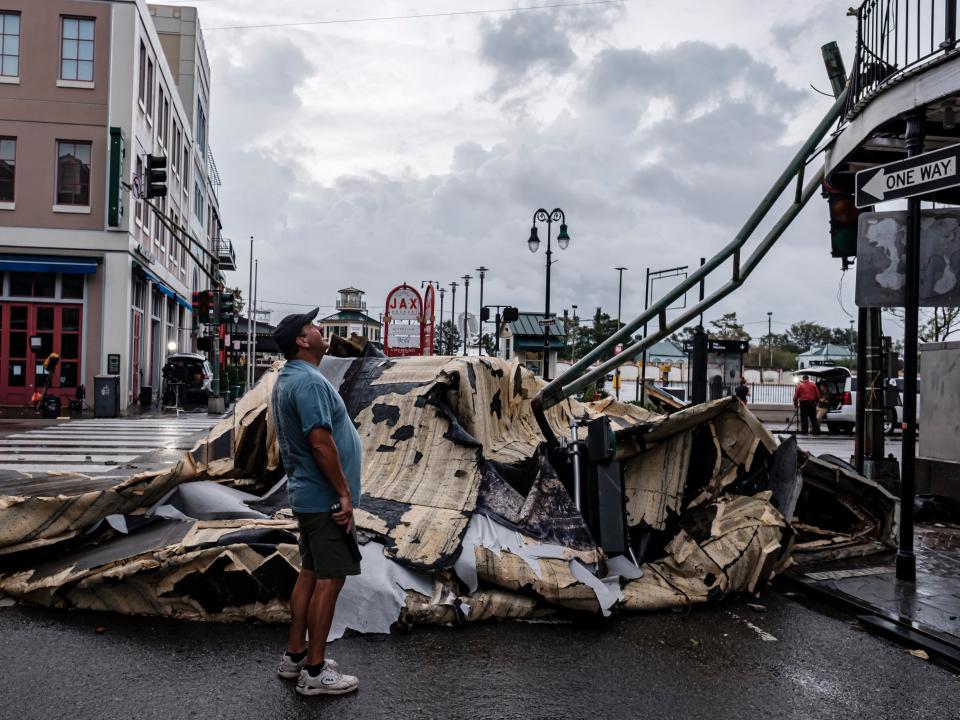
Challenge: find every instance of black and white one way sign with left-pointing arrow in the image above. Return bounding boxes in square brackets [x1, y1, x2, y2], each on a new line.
[856, 145, 960, 208]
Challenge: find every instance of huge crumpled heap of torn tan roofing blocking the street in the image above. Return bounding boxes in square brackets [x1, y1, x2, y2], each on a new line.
[0, 353, 897, 637]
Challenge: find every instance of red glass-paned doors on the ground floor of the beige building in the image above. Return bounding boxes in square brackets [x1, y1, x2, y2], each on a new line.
[0, 302, 83, 405]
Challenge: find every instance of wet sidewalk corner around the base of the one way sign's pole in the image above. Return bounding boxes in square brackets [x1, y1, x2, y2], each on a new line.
[787, 524, 960, 670]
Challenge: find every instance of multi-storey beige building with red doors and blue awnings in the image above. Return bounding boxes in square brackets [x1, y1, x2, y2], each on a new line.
[0, 0, 232, 409]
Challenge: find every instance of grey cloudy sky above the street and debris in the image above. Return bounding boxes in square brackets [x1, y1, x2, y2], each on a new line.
[169, 0, 868, 335]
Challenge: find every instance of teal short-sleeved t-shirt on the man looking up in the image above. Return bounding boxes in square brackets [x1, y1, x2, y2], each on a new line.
[273, 360, 363, 513]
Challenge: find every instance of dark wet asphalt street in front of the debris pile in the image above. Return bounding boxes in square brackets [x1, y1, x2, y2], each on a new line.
[0, 591, 960, 720]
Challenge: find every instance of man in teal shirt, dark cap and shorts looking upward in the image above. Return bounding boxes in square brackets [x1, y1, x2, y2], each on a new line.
[271, 308, 363, 695]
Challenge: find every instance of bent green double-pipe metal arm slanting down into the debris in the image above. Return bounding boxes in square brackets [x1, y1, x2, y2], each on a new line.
[532, 88, 849, 442]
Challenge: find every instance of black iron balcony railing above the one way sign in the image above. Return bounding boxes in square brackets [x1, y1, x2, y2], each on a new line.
[844, 0, 957, 119]
